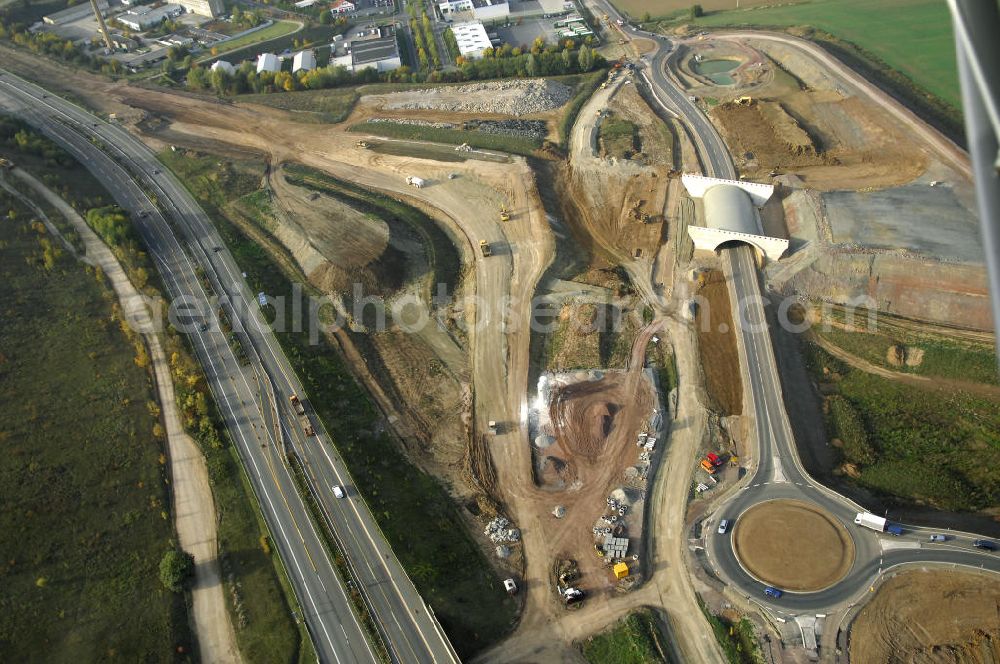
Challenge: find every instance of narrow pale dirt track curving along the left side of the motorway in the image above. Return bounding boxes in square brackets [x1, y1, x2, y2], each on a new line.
[14, 169, 240, 663]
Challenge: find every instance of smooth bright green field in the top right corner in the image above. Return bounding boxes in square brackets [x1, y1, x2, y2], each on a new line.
[695, 0, 961, 108]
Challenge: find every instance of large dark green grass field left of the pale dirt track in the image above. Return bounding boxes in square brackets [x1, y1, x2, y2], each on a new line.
[0, 188, 192, 661]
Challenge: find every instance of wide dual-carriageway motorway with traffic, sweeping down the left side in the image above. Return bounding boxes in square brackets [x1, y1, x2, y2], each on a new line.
[0, 70, 457, 662]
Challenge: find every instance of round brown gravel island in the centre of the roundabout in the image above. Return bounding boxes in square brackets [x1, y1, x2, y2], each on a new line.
[732, 500, 854, 592]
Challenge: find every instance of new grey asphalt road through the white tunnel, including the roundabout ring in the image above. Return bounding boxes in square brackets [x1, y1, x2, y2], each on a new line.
[591, 0, 1000, 614]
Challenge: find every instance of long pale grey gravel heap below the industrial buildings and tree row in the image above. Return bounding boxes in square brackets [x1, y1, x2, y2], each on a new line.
[385, 79, 573, 115]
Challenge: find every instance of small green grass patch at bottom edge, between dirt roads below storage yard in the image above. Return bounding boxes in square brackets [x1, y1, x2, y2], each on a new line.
[582, 609, 670, 664]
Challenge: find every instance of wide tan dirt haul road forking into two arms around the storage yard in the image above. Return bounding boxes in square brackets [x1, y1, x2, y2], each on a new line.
[0, 49, 721, 661]
